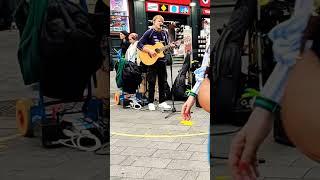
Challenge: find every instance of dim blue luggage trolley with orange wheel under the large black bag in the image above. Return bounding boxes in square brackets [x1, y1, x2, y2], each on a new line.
[16, 78, 107, 150]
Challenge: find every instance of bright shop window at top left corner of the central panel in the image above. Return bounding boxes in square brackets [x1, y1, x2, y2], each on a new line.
[110, 0, 130, 33]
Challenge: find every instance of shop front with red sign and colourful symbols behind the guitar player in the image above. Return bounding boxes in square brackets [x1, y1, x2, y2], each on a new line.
[110, 0, 206, 68]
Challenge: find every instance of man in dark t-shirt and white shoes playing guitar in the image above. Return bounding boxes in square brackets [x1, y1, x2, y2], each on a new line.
[137, 15, 175, 110]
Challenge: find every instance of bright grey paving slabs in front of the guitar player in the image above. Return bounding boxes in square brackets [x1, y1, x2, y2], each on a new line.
[110, 64, 210, 180]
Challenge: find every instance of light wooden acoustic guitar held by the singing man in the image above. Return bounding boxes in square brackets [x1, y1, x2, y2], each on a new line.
[138, 40, 181, 66]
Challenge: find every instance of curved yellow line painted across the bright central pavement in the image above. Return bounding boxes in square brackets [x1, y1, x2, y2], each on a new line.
[111, 132, 208, 138]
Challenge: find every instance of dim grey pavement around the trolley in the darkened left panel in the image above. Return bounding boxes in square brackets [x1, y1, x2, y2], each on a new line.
[0, 31, 108, 180]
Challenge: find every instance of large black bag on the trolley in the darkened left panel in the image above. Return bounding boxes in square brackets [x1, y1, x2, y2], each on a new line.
[40, 0, 102, 100]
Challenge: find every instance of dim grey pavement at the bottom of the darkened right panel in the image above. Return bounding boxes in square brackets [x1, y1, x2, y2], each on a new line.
[211, 125, 320, 180]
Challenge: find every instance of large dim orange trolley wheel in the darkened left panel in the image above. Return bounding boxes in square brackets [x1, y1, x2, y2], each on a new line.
[16, 99, 33, 137]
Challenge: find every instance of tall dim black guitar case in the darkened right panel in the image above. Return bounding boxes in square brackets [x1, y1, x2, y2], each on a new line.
[211, 0, 257, 123]
